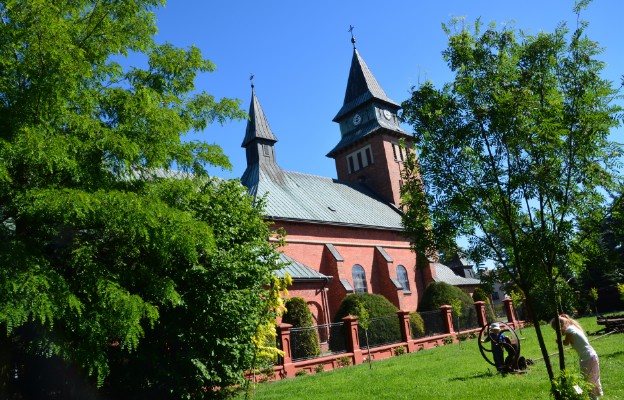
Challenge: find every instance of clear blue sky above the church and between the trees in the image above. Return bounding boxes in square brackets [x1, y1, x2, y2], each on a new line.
[150, 0, 624, 178]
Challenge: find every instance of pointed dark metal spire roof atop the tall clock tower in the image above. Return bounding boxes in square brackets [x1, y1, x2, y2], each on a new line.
[334, 45, 400, 122]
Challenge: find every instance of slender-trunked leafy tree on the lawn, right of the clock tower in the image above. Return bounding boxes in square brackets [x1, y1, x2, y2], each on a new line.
[403, 6, 621, 394]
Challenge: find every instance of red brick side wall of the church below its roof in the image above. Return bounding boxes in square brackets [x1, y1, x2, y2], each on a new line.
[276, 222, 431, 323]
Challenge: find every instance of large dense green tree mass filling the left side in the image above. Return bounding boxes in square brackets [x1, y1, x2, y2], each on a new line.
[0, 0, 278, 398]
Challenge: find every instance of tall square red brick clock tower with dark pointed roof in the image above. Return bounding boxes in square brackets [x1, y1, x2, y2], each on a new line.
[327, 37, 412, 207]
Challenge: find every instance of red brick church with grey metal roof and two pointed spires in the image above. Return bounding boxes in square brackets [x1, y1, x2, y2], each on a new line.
[241, 39, 478, 324]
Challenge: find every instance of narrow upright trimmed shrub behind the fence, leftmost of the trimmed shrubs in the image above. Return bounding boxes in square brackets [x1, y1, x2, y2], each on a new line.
[282, 297, 321, 358]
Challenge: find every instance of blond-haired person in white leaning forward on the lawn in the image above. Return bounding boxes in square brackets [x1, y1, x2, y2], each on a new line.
[550, 314, 602, 398]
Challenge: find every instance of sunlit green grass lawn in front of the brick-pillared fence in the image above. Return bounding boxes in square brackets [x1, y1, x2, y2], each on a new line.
[239, 317, 624, 400]
